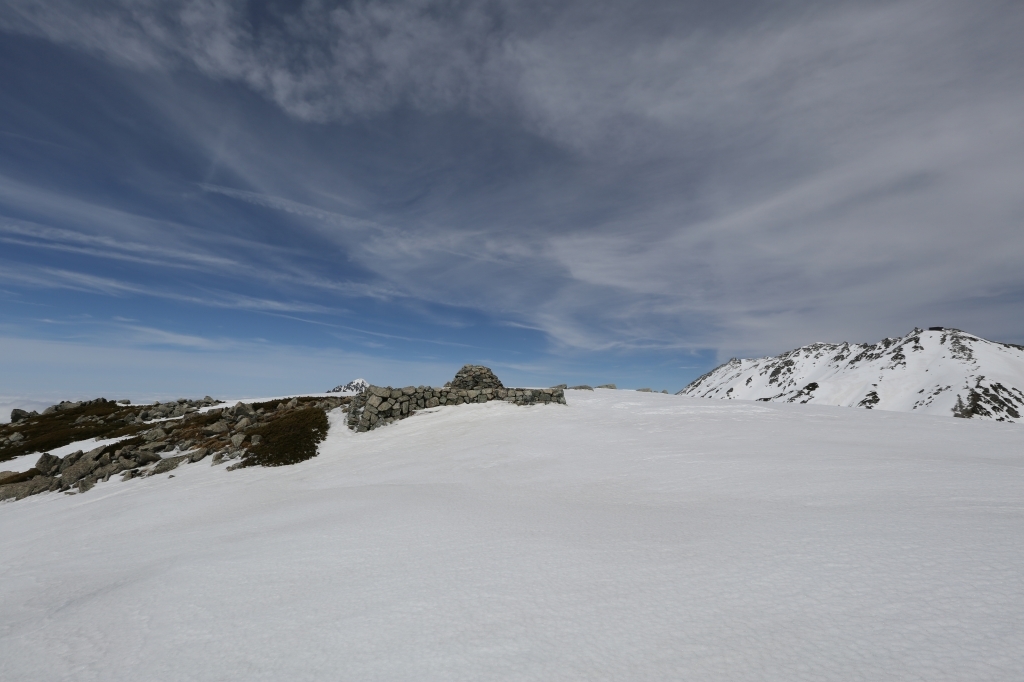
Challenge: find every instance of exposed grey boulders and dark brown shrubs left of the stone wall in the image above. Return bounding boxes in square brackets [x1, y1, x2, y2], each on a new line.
[0, 396, 352, 500]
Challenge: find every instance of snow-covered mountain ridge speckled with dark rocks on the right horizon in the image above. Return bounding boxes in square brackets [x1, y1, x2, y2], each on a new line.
[678, 328, 1024, 422]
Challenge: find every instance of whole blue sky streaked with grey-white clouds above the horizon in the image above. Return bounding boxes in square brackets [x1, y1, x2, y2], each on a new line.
[0, 0, 1024, 401]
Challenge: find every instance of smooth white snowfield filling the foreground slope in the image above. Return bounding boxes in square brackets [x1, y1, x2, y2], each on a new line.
[0, 390, 1024, 682]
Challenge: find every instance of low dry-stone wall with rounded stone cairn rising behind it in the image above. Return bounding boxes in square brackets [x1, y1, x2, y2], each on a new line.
[348, 365, 565, 433]
